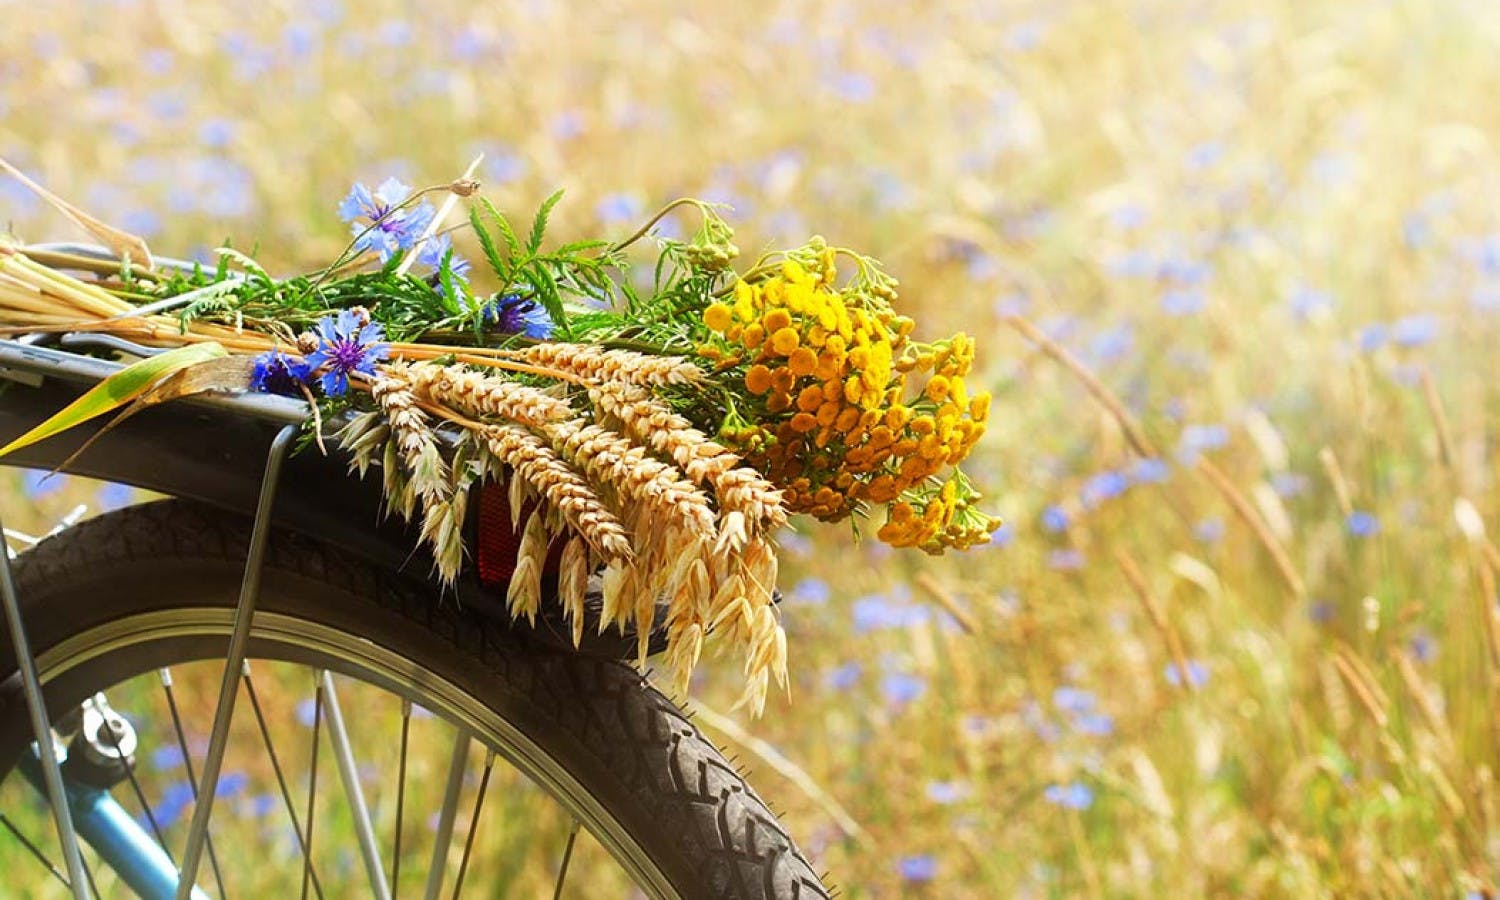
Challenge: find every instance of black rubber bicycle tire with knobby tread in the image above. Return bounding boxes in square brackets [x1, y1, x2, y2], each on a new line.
[0, 500, 830, 900]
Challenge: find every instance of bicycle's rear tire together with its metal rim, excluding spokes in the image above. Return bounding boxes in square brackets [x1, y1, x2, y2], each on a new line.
[0, 501, 827, 897]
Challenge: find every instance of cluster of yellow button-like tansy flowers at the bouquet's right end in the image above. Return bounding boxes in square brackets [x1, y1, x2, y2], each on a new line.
[699, 242, 998, 552]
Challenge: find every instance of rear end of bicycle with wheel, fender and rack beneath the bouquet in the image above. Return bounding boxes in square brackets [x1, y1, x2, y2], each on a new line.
[0, 245, 828, 899]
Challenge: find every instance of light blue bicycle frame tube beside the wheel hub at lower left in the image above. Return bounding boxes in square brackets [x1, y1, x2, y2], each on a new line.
[20, 753, 209, 900]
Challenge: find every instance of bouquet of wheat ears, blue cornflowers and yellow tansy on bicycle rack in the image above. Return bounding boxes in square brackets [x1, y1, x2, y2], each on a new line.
[0, 162, 998, 710]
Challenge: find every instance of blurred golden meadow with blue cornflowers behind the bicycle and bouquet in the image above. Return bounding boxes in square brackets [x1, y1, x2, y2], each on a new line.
[0, 0, 1500, 897]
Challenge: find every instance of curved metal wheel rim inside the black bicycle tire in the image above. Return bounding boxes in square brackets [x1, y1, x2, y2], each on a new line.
[7, 606, 678, 897]
